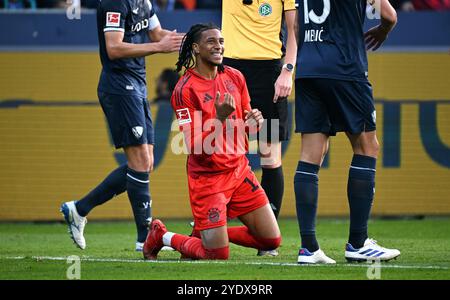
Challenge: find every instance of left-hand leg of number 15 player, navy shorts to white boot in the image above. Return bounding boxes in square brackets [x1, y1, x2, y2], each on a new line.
[294, 79, 334, 263]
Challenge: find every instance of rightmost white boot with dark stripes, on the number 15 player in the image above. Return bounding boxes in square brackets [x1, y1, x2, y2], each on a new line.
[345, 239, 400, 262]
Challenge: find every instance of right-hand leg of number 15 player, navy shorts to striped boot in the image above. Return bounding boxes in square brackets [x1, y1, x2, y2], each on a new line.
[325, 80, 400, 260]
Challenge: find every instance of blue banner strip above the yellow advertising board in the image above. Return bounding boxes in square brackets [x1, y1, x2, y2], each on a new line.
[0, 9, 450, 52]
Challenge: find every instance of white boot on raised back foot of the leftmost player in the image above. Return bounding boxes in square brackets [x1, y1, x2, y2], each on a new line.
[60, 201, 87, 250]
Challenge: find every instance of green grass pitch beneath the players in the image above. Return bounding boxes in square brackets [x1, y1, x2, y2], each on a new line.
[0, 218, 450, 280]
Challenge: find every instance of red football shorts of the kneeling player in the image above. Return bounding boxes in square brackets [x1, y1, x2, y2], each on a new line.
[188, 165, 269, 231]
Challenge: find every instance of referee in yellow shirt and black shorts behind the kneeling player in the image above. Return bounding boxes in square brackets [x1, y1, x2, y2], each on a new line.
[222, 0, 297, 256]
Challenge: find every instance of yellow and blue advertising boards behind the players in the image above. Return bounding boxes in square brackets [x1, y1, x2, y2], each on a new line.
[0, 0, 450, 221]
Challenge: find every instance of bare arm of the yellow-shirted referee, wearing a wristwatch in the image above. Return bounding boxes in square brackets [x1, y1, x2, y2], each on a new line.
[273, 9, 297, 102]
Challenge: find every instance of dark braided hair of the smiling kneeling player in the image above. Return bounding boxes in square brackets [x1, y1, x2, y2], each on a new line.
[176, 23, 224, 72]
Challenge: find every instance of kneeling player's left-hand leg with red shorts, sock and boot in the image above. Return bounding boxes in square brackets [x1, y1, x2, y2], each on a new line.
[144, 172, 236, 259]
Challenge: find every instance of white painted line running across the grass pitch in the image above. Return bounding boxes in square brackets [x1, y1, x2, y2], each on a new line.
[2, 256, 450, 270]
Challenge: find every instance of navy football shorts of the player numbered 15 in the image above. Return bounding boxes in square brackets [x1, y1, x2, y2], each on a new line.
[295, 78, 376, 136]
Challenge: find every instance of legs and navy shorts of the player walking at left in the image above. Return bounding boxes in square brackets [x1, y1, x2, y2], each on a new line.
[66, 93, 154, 251]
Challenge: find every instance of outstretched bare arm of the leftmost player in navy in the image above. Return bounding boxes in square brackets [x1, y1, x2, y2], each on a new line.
[105, 31, 181, 60]
